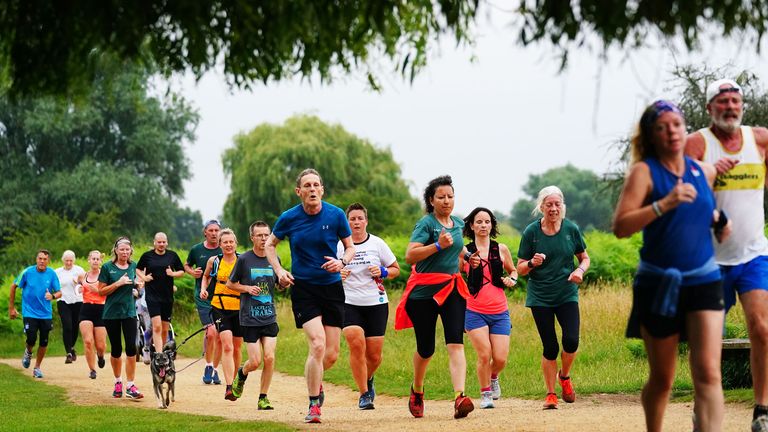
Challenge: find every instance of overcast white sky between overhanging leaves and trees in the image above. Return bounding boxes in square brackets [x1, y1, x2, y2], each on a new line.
[175, 12, 768, 219]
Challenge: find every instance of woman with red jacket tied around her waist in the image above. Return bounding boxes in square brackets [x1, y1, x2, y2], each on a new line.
[395, 176, 480, 418]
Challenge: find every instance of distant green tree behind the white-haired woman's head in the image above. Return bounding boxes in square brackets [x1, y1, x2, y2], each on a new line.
[510, 164, 613, 232]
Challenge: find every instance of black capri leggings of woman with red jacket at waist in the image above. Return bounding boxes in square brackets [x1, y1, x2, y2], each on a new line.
[405, 289, 467, 358]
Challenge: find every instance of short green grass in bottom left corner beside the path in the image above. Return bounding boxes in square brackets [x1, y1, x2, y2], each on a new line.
[0, 365, 294, 432]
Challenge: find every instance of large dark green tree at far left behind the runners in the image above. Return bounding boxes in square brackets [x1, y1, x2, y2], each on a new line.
[0, 58, 198, 233]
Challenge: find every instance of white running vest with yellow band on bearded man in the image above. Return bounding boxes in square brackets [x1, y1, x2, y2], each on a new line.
[698, 126, 768, 265]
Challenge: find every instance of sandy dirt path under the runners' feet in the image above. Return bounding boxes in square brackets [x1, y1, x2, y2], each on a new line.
[0, 356, 752, 432]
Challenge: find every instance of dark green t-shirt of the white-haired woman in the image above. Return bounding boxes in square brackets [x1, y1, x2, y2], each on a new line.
[517, 219, 587, 307]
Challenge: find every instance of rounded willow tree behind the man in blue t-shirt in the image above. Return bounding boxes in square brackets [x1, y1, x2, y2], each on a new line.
[222, 116, 420, 238]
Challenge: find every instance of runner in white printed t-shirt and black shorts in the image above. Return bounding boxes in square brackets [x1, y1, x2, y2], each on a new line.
[337, 203, 400, 410]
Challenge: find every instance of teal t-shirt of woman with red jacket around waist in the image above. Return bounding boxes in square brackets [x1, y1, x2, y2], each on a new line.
[408, 213, 464, 300]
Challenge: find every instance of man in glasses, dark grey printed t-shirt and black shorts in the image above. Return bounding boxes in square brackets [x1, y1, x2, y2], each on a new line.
[227, 221, 280, 410]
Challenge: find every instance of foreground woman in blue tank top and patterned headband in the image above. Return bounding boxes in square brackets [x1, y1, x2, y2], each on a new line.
[613, 101, 730, 432]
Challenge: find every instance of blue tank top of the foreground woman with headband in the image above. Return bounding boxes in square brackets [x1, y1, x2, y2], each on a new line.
[640, 157, 720, 285]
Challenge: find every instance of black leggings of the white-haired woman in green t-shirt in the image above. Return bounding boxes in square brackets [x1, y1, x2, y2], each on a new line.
[531, 302, 580, 360]
